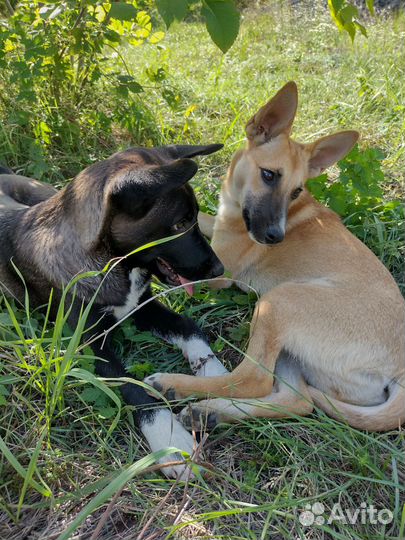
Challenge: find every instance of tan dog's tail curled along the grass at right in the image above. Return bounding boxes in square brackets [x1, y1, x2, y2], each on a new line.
[309, 376, 405, 431]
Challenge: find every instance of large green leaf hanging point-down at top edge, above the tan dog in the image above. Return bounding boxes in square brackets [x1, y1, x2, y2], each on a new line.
[201, 0, 240, 53]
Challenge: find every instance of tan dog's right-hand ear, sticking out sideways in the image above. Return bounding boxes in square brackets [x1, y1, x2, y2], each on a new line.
[308, 131, 359, 178]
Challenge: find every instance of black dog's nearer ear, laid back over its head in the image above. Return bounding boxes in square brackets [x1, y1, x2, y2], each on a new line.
[110, 159, 198, 214]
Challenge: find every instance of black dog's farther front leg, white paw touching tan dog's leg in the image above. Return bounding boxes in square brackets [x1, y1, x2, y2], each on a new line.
[133, 300, 228, 377]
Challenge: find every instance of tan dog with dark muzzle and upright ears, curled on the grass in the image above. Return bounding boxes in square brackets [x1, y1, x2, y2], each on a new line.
[145, 82, 405, 431]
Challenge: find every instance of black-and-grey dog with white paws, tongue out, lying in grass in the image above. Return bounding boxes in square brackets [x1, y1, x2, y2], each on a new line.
[0, 144, 226, 478]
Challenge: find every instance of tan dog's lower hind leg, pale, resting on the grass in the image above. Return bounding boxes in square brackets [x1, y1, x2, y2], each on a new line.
[178, 353, 313, 430]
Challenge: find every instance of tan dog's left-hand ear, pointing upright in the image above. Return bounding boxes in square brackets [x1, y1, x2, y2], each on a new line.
[245, 81, 298, 145]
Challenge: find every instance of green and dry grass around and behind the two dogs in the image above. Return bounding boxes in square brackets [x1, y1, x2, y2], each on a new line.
[0, 4, 405, 540]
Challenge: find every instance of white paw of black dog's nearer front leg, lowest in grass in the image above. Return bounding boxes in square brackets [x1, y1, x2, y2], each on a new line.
[141, 409, 198, 480]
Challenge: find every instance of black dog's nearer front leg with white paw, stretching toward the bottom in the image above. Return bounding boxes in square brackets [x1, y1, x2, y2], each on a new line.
[76, 310, 199, 480]
